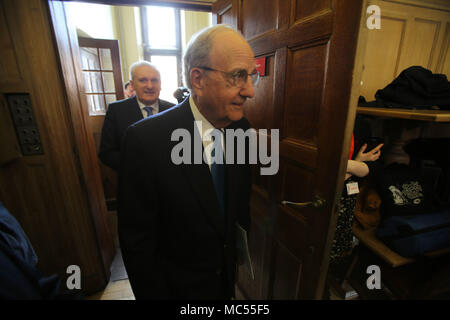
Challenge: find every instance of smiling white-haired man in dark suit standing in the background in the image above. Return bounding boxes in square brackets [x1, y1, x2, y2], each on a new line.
[99, 61, 174, 171]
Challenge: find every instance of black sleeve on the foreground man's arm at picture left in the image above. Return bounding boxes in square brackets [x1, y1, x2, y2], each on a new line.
[117, 127, 168, 299]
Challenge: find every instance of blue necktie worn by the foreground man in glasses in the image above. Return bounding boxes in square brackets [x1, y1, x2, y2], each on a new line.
[211, 129, 226, 215]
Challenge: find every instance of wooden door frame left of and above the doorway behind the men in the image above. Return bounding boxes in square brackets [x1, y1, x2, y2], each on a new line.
[44, 0, 212, 278]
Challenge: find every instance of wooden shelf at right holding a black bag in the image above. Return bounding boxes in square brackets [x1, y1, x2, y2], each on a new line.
[357, 107, 450, 122]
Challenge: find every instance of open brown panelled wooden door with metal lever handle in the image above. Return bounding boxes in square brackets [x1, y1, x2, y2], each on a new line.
[213, 0, 361, 299]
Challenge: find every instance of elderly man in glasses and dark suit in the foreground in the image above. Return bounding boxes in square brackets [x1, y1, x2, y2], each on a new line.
[118, 25, 259, 300]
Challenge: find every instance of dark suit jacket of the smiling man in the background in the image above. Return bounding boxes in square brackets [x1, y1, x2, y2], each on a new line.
[98, 96, 174, 171]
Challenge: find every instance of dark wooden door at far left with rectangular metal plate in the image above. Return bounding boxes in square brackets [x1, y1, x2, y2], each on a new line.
[0, 0, 114, 294]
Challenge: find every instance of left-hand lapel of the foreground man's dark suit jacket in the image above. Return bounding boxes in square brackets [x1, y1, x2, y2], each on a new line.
[175, 100, 225, 236]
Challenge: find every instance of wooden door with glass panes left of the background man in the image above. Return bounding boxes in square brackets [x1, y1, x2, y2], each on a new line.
[78, 37, 124, 203]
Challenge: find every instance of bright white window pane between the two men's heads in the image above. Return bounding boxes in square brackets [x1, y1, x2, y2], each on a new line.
[151, 56, 178, 103]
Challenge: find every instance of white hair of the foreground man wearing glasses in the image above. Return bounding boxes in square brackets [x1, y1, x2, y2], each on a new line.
[183, 24, 242, 89]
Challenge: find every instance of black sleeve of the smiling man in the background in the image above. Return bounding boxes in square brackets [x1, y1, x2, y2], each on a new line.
[98, 105, 120, 171]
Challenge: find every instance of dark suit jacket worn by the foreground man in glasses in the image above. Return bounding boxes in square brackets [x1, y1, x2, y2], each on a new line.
[118, 99, 251, 299]
